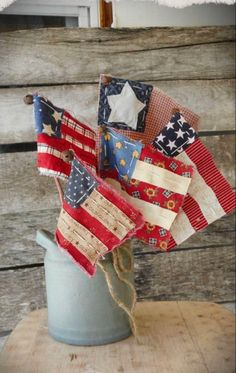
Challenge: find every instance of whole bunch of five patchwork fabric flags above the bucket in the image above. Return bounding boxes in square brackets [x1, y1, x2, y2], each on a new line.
[30, 75, 235, 276]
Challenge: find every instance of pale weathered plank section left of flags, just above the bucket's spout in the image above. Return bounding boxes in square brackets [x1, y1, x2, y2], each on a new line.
[0, 152, 60, 214]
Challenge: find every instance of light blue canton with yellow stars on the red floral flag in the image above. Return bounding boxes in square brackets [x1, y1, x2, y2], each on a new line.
[100, 128, 143, 180]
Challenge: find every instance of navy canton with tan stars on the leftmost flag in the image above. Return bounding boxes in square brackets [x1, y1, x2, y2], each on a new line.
[34, 95, 64, 138]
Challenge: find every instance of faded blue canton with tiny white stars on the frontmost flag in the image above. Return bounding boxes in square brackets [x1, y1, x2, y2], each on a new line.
[64, 159, 98, 208]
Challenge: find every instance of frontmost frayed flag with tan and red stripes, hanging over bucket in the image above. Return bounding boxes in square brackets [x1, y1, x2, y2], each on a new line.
[56, 158, 144, 276]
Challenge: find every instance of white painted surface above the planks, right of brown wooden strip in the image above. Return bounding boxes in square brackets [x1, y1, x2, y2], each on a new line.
[112, 0, 235, 27]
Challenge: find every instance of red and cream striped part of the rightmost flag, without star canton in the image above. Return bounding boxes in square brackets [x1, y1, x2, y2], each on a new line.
[168, 139, 235, 249]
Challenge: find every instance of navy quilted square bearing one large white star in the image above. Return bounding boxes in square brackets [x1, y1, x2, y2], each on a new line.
[98, 75, 153, 132]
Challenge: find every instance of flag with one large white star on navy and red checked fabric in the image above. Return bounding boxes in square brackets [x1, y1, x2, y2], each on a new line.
[98, 75, 199, 144]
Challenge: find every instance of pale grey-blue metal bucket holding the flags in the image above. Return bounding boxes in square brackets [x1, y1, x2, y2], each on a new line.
[36, 230, 133, 346]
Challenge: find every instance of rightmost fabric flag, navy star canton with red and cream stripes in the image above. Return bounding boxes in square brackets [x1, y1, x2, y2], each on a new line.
[152, 117, 235, 249]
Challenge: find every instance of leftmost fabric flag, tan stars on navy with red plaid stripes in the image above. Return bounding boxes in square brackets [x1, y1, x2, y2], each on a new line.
[34, 95, 97, 178]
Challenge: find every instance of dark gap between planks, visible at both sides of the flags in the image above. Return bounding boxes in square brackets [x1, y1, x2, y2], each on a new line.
[0, 130, 236, 154]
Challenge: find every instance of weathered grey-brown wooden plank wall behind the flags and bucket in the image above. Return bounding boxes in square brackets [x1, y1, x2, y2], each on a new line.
[0, 27, 235, 335]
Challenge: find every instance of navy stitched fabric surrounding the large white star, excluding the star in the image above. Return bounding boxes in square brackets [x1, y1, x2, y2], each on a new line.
[98, 77, 153, 132]
